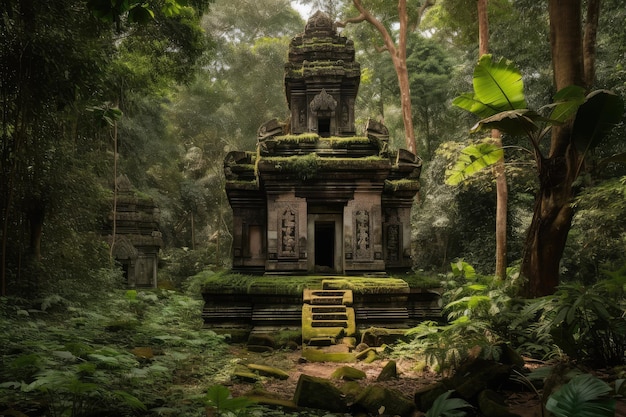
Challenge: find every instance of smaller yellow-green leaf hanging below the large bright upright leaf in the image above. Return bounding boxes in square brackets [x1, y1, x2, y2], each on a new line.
[446, 139, 504, 186]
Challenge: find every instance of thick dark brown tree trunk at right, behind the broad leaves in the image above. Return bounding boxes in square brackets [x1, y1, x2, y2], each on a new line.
[522, 0, 584, 297]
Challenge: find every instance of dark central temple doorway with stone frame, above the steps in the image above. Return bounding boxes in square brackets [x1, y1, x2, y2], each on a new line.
[307, 211, 343, 274]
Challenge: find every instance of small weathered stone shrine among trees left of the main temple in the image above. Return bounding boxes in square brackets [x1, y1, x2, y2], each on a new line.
[104, 175, 163, 288]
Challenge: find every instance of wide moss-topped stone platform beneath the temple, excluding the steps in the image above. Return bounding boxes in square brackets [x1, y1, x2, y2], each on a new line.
[201, 272, 441, 339]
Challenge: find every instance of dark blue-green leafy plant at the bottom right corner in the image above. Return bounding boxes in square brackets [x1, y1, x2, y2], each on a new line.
[546, 374, 615, 417]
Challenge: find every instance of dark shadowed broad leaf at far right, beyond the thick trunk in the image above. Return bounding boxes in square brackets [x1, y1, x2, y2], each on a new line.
[572, 90, 624, 152]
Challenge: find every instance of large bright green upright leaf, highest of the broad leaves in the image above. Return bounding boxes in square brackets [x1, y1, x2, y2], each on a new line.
[473, 54, 527, 112]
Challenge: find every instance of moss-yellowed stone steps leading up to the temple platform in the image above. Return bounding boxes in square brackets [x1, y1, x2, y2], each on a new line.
[302, 289, 356, 346]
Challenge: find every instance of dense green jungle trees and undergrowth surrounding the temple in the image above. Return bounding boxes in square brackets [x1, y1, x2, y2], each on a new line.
[0, 0, 626, 416]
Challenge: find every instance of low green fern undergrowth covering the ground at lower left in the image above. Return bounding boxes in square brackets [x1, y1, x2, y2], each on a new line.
[0, 271, 229, 416]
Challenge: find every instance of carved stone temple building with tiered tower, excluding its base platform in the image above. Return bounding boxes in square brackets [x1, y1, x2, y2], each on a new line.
[224, 12, 421, 275]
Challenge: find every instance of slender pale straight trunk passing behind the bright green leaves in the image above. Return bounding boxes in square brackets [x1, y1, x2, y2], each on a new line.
[476, 0, 509, 279]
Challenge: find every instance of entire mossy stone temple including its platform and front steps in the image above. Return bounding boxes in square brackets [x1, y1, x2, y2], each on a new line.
[202, 12, 441, 346]
